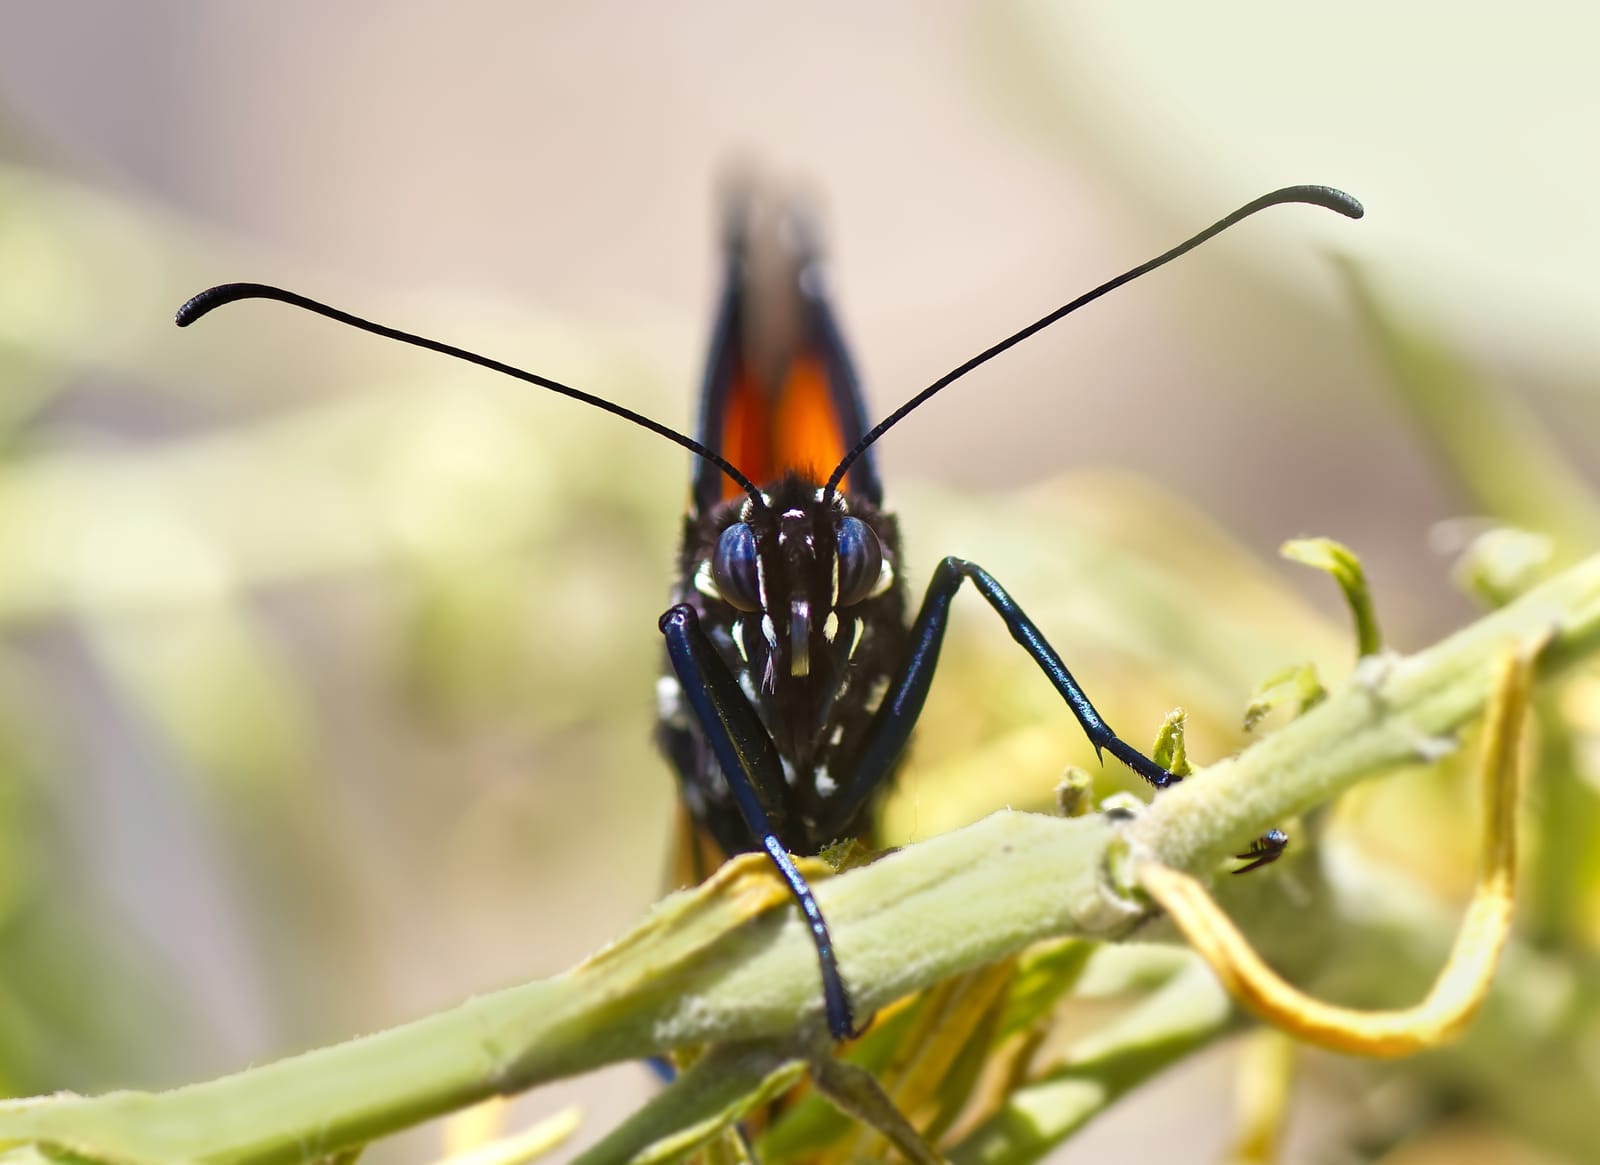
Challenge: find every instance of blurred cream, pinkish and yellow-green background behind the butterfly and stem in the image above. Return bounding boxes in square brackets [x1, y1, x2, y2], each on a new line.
[0, 0, 1600, 1162]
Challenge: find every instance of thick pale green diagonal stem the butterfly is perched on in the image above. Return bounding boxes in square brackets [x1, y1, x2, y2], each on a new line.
[0, 557, 1600, 1165]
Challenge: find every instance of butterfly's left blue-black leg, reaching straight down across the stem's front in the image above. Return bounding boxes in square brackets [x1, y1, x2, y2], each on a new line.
[661, 603, 856, 1040]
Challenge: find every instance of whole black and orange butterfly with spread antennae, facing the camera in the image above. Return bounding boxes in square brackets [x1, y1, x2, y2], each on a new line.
[178, 186, 1363, 1039]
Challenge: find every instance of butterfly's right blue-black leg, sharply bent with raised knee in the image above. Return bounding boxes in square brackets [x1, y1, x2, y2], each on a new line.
[838, 557, 1179, 838]
